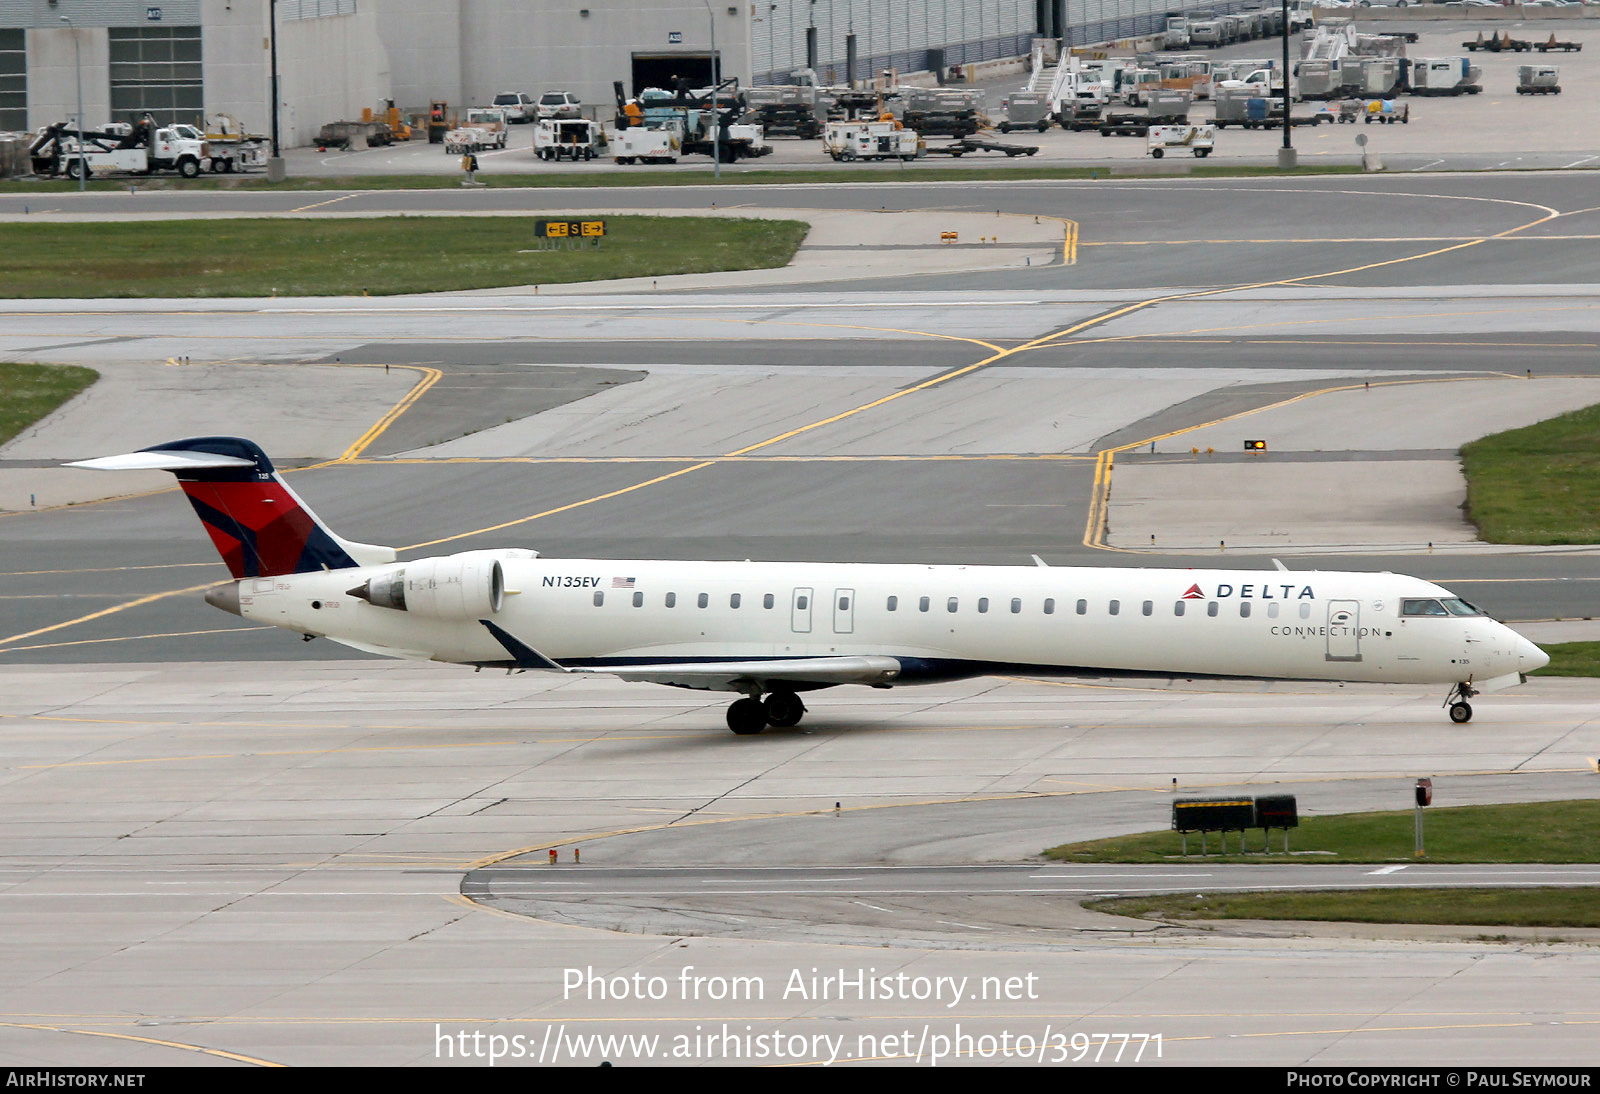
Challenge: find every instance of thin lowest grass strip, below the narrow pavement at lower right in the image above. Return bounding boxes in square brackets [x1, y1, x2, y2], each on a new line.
[1083, 888, 1600, 928]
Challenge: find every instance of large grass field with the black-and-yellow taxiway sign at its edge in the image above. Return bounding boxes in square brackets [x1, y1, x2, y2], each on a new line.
[0, 214, 808, 297]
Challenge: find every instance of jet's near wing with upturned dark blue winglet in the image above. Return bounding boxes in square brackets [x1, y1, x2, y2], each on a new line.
[478, 619, 901, 691]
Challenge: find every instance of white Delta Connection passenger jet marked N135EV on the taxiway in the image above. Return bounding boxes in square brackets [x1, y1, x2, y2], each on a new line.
[70, 437, 1549, 734]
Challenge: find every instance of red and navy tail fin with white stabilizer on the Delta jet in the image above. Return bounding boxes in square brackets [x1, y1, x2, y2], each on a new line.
[67, 437, 395, 577]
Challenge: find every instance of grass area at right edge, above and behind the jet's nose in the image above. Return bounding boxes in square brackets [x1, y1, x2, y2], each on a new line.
[1461, 406, 1600, 544]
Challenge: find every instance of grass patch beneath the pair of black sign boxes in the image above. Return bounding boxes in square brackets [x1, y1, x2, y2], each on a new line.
[1045, 800, 1600, 864]
